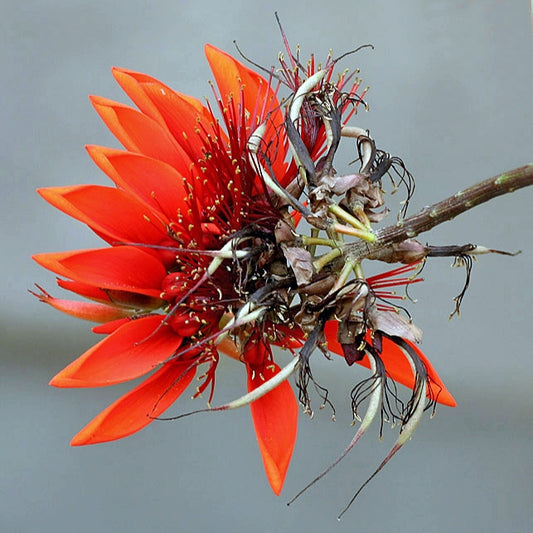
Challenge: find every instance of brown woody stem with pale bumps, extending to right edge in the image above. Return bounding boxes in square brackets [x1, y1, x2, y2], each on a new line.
[345, 163, 533, 261]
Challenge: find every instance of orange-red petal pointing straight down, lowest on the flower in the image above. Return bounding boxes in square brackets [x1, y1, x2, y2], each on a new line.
[246, 363, 298, 496]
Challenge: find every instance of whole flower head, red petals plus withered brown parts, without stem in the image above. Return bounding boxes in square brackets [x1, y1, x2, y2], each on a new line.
[34, 40, 455, 502]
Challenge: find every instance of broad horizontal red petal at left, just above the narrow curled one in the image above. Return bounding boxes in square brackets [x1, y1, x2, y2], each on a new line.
[33, 246, 167, 298]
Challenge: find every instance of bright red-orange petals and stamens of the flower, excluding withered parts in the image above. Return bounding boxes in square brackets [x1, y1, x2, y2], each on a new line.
[34, 40, 454, 494]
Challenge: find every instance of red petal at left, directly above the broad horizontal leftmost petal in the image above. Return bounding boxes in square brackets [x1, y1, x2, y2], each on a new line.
[37, 185, 167, 244]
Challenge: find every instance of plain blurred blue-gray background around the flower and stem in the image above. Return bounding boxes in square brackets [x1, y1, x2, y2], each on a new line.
[0, 0, 533, 532]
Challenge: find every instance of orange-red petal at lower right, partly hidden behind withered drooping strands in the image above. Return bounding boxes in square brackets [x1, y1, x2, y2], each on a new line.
[324, 320, 457, 407]
